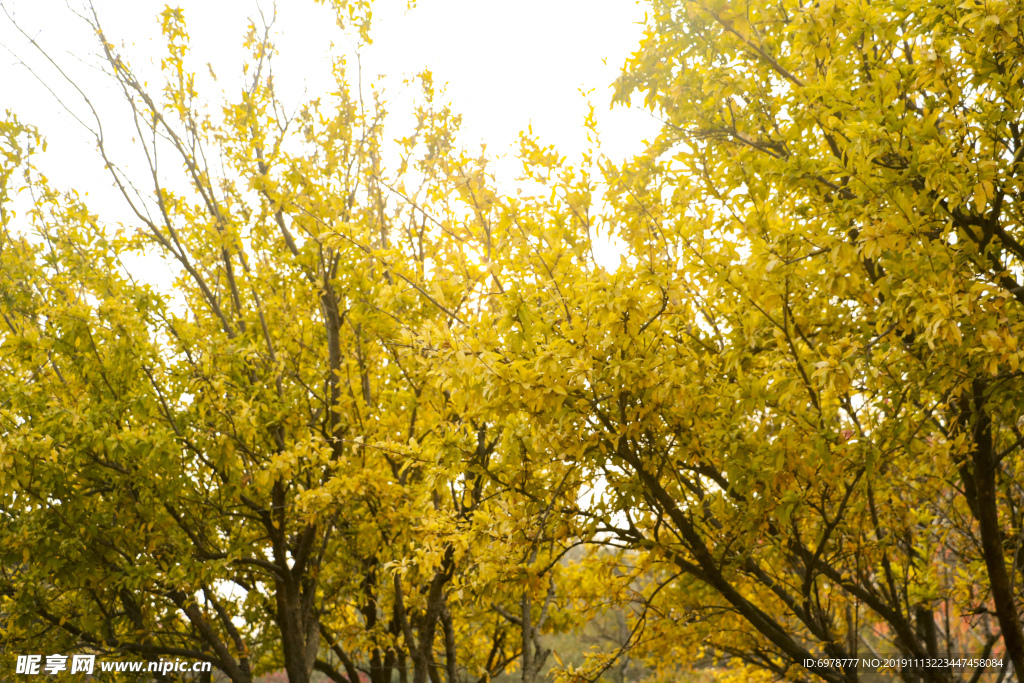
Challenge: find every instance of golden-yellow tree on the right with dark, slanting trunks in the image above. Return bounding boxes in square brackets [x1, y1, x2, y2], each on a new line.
[428, 0, 1024, 681]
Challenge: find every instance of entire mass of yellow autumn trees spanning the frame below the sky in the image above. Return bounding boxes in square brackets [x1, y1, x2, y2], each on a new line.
[0, 0, 1024, 683]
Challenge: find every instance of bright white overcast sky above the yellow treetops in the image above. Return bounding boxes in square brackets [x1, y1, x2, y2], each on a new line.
[0, 0, 656, 201]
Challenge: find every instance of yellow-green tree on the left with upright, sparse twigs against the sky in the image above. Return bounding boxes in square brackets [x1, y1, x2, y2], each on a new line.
[0, 3, 577, 683]
